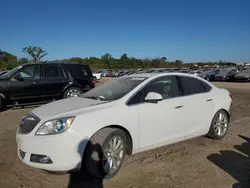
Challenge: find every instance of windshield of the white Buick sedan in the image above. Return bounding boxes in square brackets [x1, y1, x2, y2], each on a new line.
[81, 76, 147, 101]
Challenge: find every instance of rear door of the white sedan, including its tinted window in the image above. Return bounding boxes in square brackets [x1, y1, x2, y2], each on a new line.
[177, 76, 214, 137]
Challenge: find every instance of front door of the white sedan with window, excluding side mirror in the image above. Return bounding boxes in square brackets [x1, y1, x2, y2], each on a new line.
[128, 76, 185, 150]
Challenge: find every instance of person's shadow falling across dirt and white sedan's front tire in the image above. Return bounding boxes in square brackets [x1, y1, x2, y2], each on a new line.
[68, 140, 103, 188]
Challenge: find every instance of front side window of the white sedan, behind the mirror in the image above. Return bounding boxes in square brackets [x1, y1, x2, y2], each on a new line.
[128, 76, 178, 105]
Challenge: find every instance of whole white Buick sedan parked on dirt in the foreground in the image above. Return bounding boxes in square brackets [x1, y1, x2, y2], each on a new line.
[16, 73, 232, 178]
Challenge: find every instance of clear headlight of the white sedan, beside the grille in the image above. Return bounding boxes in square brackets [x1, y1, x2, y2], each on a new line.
[36, 117, 75, 135]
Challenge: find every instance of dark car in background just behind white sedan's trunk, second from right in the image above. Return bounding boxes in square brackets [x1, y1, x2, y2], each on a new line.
[214, 68, 239, 81]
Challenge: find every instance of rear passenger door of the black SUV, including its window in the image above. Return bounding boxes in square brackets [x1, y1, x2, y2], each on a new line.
[39, 64, 67, 98]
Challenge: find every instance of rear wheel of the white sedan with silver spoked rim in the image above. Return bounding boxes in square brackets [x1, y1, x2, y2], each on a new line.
[207, 110, 229, 140]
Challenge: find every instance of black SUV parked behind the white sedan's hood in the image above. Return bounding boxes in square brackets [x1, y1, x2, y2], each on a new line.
[0, 63, 95, 109]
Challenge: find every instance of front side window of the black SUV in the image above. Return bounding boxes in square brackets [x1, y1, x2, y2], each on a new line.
[19, 65, 40, 79]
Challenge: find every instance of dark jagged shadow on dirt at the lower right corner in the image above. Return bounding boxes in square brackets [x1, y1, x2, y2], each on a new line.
[207, 135, 250, 188]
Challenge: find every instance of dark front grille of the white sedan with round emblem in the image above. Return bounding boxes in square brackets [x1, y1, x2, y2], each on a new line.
[18, 114, 40, 134]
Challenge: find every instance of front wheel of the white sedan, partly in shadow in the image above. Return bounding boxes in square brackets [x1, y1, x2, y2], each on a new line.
[83, 128, 126, 179]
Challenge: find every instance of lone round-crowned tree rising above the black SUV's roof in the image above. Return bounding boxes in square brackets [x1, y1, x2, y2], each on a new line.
[22, 46, 47, 63]
